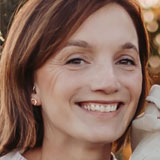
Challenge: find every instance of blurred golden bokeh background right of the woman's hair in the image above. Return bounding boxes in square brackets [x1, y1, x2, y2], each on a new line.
[138, 0, 160, 84]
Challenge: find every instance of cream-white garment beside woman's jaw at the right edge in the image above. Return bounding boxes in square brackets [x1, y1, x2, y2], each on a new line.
[130, 85, 160, 160]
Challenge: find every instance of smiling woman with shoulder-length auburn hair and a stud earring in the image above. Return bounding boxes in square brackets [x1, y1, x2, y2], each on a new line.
[0, 0, 148, 160]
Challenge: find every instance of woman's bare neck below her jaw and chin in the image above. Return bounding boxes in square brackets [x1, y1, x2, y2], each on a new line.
[24, 129, 112, 160]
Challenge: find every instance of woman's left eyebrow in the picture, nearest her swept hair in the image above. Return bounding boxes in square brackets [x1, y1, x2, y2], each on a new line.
[65, 40, 92, 49]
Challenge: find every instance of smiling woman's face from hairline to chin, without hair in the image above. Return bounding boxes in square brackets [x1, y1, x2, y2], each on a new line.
[32, 3, 142, 143]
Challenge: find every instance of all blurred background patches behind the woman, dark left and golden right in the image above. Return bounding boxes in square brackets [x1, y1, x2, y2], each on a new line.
[0, 0, 160, 160]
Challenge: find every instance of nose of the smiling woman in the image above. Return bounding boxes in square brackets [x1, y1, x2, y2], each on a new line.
[90, 65, 121, 94]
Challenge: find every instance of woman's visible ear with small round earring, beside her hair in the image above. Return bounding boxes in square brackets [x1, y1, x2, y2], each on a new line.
[31, 86, 41, 106]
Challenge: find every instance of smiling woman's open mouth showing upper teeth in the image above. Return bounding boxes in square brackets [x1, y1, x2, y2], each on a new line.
[77, 102, 123, 113]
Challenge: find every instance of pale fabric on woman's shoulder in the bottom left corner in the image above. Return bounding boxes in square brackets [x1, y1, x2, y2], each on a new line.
[0, 151, 26, 160]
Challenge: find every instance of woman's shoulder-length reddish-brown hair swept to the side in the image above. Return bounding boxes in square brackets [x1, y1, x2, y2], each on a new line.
[0, 0, 149, 156]
